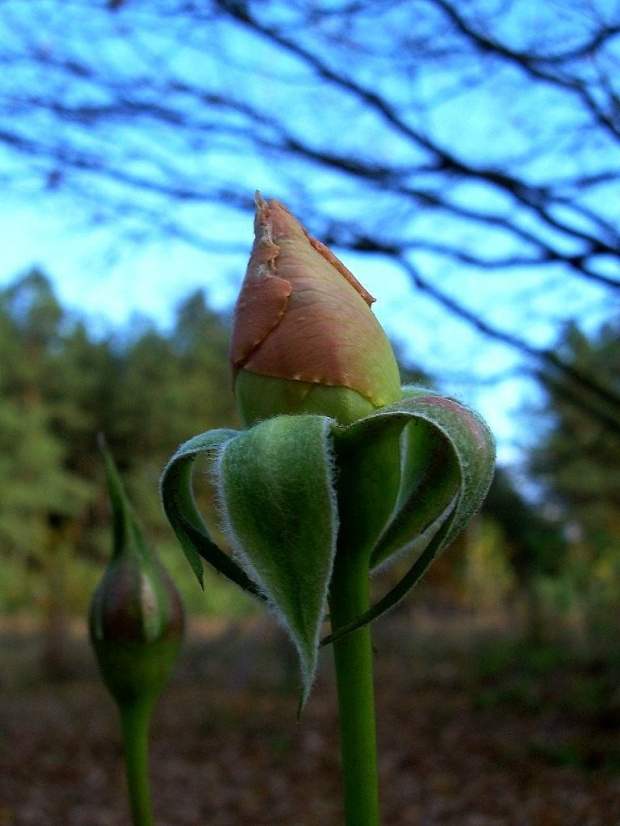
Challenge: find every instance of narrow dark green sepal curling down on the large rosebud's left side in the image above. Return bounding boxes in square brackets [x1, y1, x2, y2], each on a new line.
[160, 428, 261, 598]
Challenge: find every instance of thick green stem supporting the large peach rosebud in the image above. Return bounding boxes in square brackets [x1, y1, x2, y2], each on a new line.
[329, 554, 379, 826]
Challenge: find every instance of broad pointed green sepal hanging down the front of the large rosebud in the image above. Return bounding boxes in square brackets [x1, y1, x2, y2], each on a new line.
[216, 415, 338, 706]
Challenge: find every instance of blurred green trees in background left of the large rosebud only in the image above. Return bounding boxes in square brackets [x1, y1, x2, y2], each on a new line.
[0, 270, 235, 611]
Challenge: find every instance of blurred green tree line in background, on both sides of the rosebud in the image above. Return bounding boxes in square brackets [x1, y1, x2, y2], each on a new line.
[0, 270, 620, 648]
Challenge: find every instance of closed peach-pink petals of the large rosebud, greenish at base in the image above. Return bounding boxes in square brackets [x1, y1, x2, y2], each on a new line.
[230, 193, 401, 426]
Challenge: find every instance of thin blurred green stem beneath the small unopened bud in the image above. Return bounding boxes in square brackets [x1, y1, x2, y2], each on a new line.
[120, 700, 154, 826]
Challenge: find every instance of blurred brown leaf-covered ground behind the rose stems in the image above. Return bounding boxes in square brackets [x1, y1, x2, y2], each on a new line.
[0, 616, 620, 826]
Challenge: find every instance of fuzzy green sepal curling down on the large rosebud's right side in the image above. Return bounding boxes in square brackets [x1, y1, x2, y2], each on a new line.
[322, 392, 495, 645]
